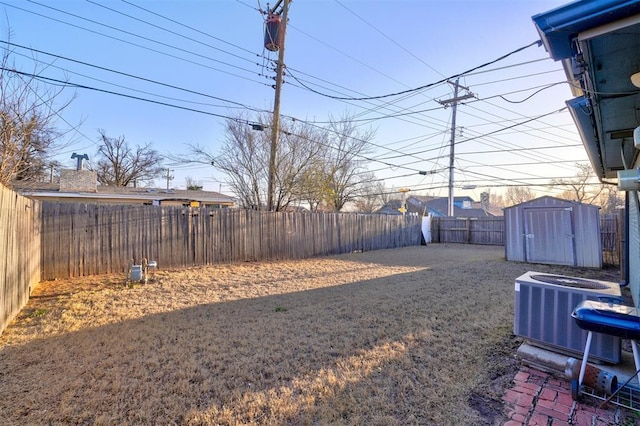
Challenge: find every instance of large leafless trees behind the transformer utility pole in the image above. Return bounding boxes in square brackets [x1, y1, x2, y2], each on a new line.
[172, 110, 372, 211]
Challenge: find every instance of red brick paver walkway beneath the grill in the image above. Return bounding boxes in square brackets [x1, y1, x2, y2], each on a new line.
[502, 366, 636, 426]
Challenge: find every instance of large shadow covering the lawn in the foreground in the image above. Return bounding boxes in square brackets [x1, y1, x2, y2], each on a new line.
[0, 245, 620, 424]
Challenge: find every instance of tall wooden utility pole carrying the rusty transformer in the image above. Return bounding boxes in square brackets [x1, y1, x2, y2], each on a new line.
[267, 0, 289, 211]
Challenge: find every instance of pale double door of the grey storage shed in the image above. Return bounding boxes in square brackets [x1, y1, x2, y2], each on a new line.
[524, 207, 576, 266]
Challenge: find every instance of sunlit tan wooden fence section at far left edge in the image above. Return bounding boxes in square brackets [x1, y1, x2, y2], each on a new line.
[0, 185, 40, 333]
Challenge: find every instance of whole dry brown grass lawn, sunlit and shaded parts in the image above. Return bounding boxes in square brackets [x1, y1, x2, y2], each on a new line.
[0, 245, 616, 425]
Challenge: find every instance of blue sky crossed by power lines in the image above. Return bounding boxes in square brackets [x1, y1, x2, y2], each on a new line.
[0, 0, 586, 199]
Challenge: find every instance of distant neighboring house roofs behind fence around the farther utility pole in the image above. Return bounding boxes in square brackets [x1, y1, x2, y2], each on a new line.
[376, 195, 495, 218]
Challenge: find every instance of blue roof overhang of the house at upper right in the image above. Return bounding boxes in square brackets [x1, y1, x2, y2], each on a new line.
[532, 0, 640, 179]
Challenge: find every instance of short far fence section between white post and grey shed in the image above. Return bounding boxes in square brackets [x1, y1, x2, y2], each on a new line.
[431, 216, 504, 246]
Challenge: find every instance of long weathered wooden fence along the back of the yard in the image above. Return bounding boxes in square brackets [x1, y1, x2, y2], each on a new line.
[42, 202, 421, 280]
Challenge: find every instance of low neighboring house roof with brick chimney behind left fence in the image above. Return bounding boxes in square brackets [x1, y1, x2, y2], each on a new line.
[12, 170, 235, 208]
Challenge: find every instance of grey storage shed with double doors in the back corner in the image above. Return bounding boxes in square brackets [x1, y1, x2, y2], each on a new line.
[504, 196, 602, 268]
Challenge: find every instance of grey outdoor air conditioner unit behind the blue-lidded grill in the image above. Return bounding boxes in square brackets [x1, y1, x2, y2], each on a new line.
[513, 271, 622, 364]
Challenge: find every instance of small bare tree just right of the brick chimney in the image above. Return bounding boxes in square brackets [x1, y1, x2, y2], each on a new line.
[95, 130, 163, 186]
